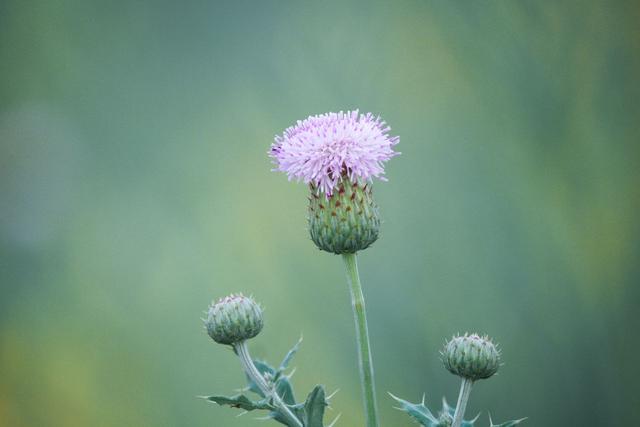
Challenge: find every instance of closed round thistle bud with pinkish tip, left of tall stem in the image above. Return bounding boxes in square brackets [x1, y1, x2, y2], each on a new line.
[205, 294, 264, 344]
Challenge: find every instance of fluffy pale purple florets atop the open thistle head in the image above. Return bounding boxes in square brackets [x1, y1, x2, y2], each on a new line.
[269, 110, 400, 196]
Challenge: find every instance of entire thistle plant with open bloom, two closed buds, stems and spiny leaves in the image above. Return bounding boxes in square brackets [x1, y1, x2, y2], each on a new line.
[199, 111, 522, 427]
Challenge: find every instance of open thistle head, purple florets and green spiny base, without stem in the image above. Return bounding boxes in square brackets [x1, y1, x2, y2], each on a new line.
[269, 111, 399, 254]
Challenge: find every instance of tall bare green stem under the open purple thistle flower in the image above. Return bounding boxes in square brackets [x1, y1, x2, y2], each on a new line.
[342, 253, 379, 427]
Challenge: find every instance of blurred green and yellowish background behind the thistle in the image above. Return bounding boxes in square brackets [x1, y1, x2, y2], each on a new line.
[0, 0, 640, 427]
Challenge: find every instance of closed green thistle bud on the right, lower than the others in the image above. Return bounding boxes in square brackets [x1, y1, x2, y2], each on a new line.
[442, 334, 500, 381]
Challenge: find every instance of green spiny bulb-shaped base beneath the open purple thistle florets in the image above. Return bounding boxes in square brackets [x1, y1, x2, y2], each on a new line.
[309, 176, 380, 254]
